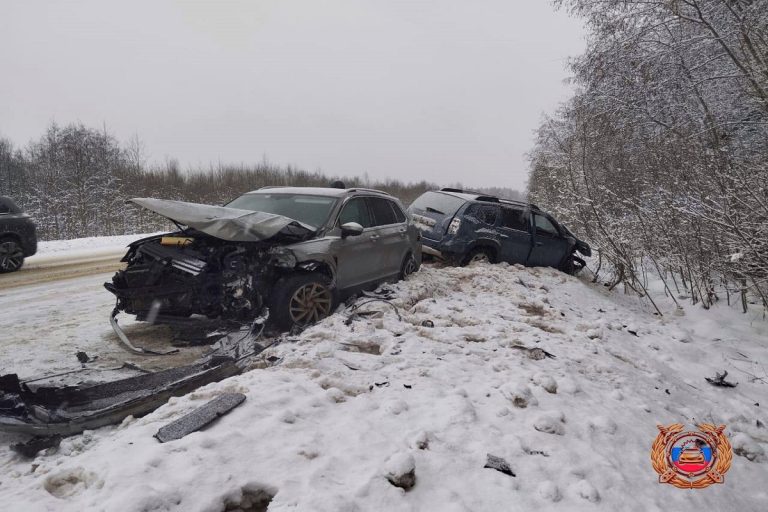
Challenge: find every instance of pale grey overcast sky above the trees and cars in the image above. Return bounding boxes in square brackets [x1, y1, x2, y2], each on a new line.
[0, 0, 584, 188]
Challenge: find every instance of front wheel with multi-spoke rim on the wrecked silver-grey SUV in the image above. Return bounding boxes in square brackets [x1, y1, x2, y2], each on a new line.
[269, 272, 336, 331]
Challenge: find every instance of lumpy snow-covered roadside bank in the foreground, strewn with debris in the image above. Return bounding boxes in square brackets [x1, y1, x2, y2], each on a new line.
[0, 264, 768, 512]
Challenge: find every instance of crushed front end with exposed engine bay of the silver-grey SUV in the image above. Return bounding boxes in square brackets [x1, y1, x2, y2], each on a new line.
[104, 230, 288, 322]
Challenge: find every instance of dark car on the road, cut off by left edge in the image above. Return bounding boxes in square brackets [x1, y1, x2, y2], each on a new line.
[0, 196, 37, 274]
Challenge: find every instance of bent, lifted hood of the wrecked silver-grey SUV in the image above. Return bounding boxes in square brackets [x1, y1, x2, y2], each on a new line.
[128, 197, 316, 242]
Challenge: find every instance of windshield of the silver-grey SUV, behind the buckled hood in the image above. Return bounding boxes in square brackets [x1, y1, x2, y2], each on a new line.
[226, 193, 336, 229]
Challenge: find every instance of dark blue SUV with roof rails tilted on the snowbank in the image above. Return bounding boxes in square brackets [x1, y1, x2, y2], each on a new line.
[408, 188, 592, 273]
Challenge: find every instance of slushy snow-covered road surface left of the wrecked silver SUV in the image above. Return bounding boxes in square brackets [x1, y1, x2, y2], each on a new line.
[0, 268, 207, 383]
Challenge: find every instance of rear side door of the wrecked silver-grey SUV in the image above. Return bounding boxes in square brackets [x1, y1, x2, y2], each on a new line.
[366, 197, 408, 279]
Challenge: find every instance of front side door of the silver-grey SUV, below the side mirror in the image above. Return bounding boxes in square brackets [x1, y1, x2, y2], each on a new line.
[334, 197, 386, 290]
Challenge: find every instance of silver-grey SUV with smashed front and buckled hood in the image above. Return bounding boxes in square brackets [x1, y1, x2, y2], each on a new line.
[105, 187, 421, 329]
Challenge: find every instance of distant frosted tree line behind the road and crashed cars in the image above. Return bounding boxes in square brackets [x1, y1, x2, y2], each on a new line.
[0, 123, 519, 240]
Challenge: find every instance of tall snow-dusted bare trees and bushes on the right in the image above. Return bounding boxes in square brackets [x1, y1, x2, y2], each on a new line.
[528, 0, 768, 312]
